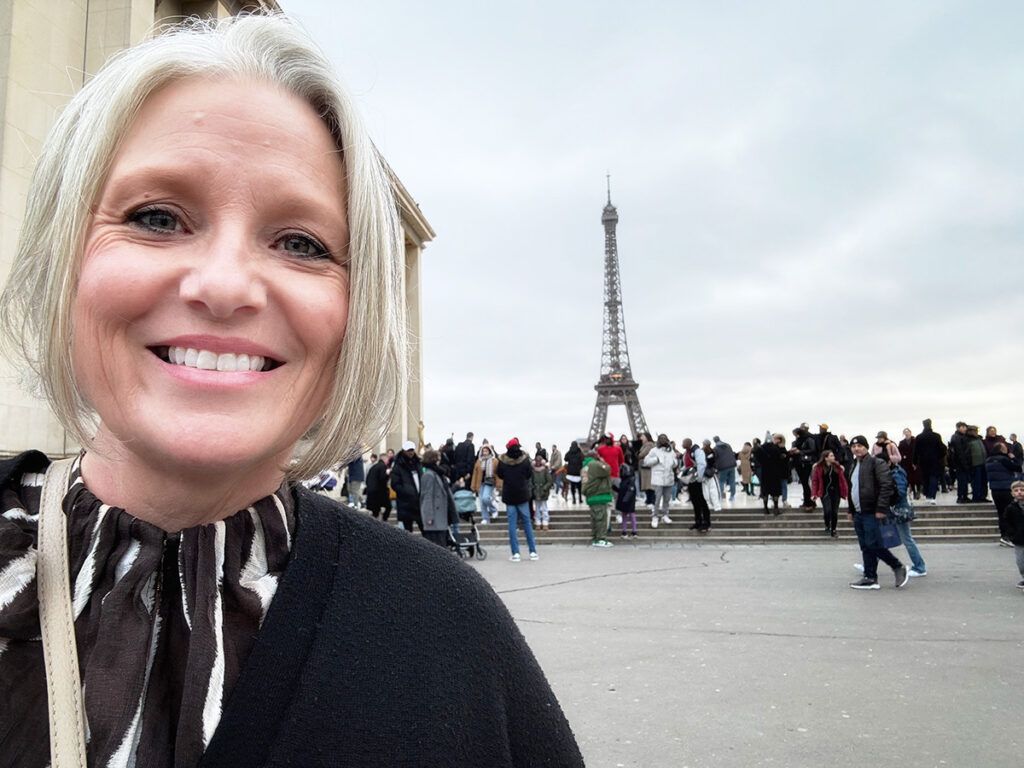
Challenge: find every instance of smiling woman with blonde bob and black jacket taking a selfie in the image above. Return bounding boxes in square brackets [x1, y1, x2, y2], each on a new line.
[0, 16, 582, 768]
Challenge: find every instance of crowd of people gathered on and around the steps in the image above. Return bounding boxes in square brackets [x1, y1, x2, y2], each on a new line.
[311, 419, 1024, 590]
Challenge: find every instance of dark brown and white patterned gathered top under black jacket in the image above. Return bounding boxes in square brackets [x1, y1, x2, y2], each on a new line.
[0, 459, 295, 768]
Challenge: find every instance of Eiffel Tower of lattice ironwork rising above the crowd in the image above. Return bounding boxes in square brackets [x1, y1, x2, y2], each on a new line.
[589, 176, 647, 443]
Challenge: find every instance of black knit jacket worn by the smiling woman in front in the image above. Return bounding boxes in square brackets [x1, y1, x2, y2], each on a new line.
[0, 454, 584, 768]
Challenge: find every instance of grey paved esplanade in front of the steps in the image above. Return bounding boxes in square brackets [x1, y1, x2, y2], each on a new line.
[473, 544, 1024, 768]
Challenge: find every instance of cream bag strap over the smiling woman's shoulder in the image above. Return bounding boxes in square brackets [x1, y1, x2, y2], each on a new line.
[36, 459, 86, 768]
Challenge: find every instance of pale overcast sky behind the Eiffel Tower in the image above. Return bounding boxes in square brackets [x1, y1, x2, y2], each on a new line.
[282, 0, 1024, 445]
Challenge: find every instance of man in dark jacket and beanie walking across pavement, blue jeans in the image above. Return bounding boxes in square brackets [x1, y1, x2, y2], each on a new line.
[849, 435, 909, 590]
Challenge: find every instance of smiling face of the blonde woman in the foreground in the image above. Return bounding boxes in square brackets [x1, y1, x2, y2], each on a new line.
[73, 79, 348, 481]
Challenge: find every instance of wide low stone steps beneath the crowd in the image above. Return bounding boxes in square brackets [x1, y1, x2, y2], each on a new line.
[471, 495, 999, 547]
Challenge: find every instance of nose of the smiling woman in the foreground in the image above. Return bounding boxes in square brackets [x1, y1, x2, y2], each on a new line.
[180, 233, 266, 319]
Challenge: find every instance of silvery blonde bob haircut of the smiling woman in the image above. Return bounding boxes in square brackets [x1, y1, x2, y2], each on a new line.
[0, 14, 407, 479]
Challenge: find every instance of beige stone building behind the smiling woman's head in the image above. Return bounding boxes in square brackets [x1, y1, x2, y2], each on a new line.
[0, 0, 434, 456]
